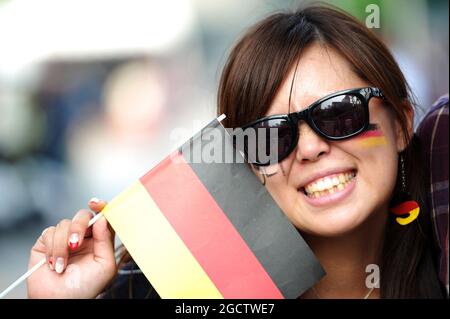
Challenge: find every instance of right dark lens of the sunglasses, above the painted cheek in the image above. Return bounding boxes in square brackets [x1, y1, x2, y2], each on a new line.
[311, 95, 367, 137]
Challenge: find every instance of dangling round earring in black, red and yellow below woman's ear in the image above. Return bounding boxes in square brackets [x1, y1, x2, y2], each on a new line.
[390, 154, 420, 225]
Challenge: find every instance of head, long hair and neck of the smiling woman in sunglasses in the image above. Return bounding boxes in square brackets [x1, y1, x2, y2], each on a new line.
[218, 6, 443, 298]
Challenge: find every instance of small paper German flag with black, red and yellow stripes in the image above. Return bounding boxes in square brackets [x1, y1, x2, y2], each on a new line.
[103, 119, 324, 299]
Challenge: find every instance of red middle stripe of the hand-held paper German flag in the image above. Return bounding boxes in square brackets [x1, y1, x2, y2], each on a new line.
[140, 152, 284, 298]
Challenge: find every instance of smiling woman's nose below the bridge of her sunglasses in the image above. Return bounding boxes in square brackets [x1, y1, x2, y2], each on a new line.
[296, 123, 330, 163]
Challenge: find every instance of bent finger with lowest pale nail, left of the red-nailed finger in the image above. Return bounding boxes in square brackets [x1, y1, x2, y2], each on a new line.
[52, 219, 72, 274]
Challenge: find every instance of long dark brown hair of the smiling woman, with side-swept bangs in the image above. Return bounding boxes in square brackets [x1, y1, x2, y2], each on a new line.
[218, 4, 443, 298]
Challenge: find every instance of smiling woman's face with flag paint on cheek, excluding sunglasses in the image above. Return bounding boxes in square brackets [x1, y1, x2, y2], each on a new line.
[265, 45, 403, 236]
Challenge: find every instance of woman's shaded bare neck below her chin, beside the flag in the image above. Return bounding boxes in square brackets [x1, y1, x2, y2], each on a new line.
[303, 210, 387, 298]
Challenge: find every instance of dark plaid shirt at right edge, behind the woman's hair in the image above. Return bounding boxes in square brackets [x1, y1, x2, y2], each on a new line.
[417, 94, 449, 296]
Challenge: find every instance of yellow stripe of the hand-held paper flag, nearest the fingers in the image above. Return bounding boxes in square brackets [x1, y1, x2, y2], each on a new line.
[103, 181, 223, 299]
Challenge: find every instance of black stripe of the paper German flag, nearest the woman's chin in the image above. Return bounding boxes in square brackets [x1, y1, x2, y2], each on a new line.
[180, 120, 325, 298]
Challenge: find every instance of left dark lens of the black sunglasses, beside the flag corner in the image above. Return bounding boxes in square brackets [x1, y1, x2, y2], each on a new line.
[240, 118, 294, 165]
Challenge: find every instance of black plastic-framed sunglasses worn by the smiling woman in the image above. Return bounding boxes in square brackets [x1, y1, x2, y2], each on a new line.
[235, 87, 384, 166]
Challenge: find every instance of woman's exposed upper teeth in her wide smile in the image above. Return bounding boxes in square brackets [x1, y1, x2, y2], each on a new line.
[304, 172, 356, 198]
